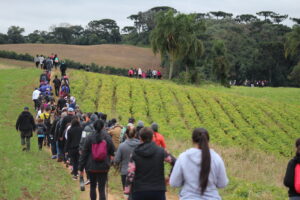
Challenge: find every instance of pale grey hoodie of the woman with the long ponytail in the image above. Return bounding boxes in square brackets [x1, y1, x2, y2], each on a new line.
[170, 148, 228, 200]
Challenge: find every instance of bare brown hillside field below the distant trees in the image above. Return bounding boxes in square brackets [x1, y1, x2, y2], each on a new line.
[0, 44, 160, 69]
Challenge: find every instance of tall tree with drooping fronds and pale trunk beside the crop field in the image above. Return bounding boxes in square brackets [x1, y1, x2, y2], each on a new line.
[150, 10, 203, 79]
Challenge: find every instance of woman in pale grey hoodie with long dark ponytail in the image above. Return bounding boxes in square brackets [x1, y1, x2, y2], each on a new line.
[170, 128, 228, 200]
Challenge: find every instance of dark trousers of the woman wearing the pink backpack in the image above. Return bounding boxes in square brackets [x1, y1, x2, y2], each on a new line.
[90, 172, 107, 200]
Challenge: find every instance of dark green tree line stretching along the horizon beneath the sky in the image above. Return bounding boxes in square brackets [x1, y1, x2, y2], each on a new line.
[0, 6, 300, 86]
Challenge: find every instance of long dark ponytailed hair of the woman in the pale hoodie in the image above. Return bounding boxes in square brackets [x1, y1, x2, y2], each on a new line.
[192, 128, 211, 195]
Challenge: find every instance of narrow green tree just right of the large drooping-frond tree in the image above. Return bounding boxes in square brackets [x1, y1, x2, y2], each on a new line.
[213, 40, 230, 87]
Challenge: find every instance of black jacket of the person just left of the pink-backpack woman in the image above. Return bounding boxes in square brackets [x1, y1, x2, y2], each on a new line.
[65, 126, 82, 153]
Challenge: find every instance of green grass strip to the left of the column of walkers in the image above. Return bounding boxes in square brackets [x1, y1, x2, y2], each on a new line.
[0, 68, 78, 200]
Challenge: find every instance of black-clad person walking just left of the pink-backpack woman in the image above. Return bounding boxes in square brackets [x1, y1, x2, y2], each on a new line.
[65, 118, 82, 180]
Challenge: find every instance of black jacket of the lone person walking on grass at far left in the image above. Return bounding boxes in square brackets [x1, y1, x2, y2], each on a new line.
[16, 111, 36, 131]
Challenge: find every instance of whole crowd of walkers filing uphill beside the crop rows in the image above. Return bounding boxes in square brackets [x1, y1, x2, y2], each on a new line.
[16, 55, 300, 200]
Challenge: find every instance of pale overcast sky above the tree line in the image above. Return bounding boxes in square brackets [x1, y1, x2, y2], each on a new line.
[0, 0, 300, 34]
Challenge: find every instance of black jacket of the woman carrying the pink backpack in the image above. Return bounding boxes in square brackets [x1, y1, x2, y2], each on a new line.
[79, 131, 115, 172]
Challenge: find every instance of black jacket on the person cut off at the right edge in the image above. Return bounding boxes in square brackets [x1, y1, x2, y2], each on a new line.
[283, 156, 300, 197]
